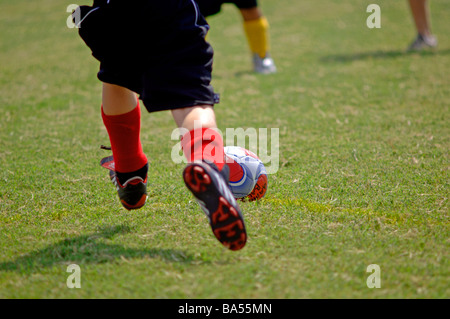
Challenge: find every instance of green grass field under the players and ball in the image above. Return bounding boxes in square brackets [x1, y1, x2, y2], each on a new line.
[0, 0, 450, 299]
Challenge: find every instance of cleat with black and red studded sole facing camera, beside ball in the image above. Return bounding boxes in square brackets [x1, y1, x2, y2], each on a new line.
[183, 161, 247, 250]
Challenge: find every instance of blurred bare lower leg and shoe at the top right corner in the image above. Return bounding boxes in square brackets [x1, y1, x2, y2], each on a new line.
[408, 0, 437, 51]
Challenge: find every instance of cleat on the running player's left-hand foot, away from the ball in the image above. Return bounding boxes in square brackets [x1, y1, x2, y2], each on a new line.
[100, 156, 147, 210]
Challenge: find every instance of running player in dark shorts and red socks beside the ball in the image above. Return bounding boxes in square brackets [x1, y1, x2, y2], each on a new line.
[74, 0, 247, 250]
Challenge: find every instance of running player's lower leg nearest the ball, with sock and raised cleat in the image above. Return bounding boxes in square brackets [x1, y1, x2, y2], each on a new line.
[172, 105, 247, 250]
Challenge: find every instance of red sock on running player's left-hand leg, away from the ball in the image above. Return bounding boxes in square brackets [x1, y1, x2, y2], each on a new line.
[102, 101, 147, 173]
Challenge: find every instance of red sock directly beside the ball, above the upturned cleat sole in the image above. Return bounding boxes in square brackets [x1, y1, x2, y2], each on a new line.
[181, 128, 224, 171]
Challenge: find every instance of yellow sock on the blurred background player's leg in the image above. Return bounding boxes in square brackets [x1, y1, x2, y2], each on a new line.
[244, 17, 270, 58]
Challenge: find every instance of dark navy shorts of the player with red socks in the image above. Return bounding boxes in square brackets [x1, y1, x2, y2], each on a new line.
[73, 0, 218, 112]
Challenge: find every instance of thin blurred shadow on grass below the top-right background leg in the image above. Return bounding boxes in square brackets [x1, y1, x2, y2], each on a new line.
[320, 49, 450, 63]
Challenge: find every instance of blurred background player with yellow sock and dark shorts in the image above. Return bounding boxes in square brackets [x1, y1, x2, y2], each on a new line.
[195, 0, 277, 74]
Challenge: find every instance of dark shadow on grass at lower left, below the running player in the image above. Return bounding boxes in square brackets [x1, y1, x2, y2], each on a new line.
[0, 225, 194, 273]
